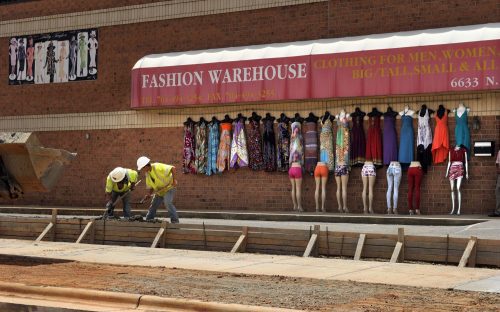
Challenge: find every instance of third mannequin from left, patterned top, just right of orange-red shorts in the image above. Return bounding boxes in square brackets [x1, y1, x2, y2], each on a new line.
[335, 109, 350, 213]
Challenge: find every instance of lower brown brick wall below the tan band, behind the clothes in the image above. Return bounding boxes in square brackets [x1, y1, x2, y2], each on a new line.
[8, 116, 500, 214]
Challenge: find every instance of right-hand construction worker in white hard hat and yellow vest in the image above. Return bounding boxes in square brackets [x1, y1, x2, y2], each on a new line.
[137, 156, 179, 223]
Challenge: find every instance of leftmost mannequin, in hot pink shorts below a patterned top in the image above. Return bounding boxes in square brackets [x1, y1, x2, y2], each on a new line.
[288, 113, 304, 212]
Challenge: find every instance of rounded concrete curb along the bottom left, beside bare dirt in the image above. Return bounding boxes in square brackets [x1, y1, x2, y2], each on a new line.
[0, 282, 298, 312]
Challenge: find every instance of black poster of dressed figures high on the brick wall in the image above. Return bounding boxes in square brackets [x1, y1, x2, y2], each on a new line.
[8, 29, 99, 85]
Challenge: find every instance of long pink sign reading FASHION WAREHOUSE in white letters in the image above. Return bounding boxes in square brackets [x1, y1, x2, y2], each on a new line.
[131, 40, 500, 108]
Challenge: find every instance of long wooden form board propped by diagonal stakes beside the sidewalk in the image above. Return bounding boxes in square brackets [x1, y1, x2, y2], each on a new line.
[0, 216, 500, 267]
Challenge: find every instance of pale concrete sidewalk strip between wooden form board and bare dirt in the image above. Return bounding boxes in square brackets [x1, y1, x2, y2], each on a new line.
[0, 239, 500, 293]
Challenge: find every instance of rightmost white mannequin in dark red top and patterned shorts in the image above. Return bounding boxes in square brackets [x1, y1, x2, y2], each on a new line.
[445, 145, 469, 215]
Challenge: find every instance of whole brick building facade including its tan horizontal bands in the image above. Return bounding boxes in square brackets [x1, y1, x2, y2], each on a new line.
[0, 0, 500, 214]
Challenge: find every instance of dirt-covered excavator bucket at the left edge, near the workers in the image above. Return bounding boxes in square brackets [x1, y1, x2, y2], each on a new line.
[0, 132, 76, 198]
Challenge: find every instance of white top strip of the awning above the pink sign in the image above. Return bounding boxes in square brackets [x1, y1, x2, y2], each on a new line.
[133, 23, 500, 69]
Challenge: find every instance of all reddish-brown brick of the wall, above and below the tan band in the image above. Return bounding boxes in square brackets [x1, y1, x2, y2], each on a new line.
[0, 0, 500, 214]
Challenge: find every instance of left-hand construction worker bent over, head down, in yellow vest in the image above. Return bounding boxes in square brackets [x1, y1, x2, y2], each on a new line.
[106, 167, 139, 218]
